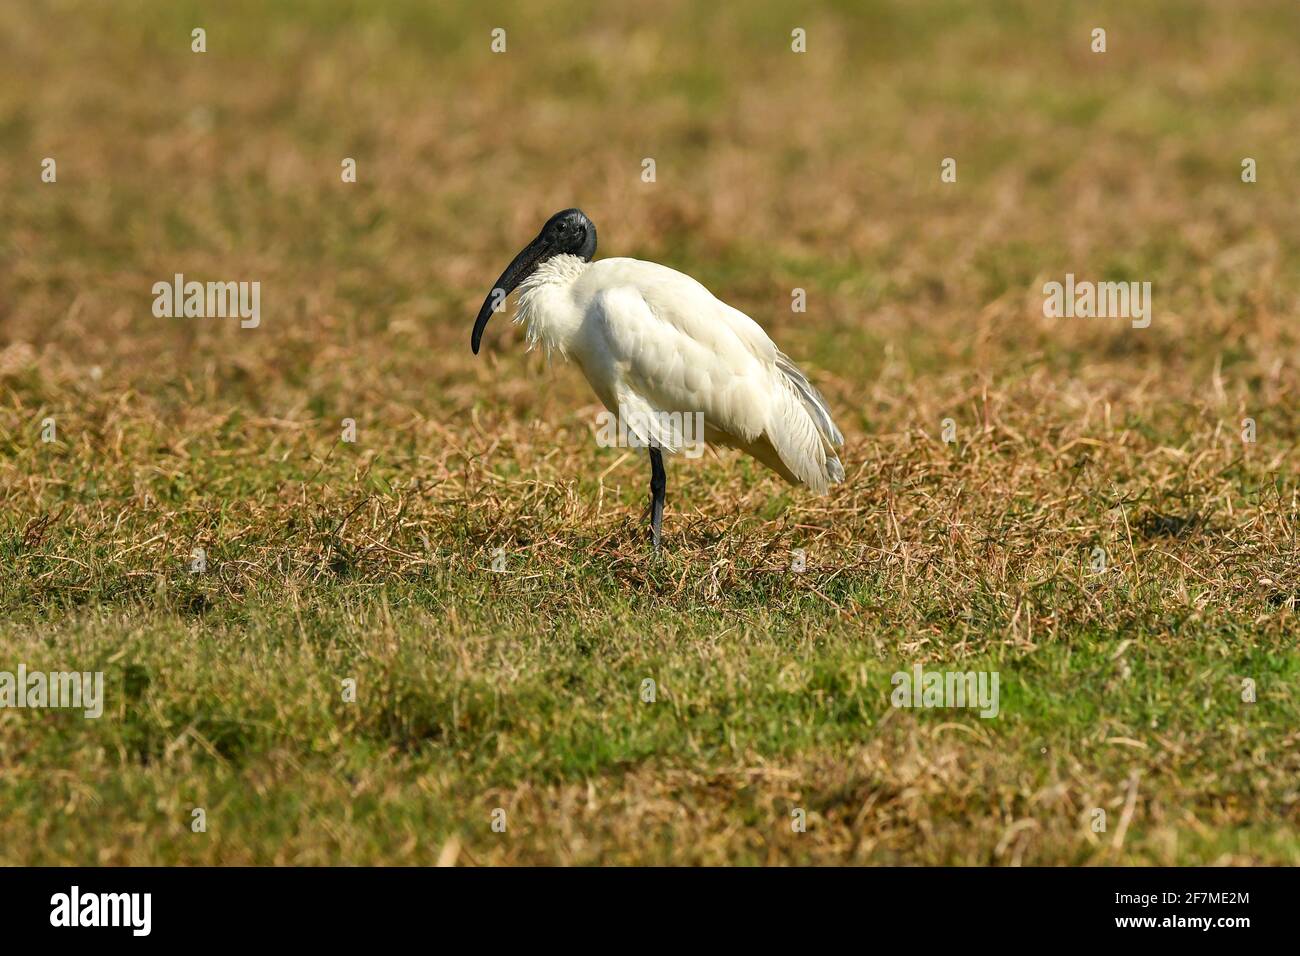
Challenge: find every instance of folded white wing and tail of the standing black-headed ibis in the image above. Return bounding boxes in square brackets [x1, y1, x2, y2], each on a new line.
[592, 260, 844, 490]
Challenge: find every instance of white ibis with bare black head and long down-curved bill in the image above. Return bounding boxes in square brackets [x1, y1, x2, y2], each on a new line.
[469, 209, 844, 550]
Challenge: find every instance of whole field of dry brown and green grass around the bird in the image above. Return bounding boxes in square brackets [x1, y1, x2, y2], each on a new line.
[0, 0, 1300, 865]
